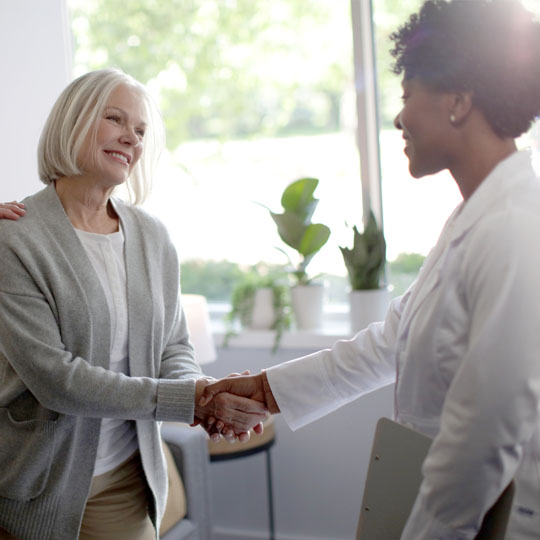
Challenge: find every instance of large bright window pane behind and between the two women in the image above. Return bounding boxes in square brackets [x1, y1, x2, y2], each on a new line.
[70, 0, 362, 300]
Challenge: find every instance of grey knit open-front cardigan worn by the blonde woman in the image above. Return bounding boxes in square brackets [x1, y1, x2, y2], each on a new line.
[0, 185, 201, 540]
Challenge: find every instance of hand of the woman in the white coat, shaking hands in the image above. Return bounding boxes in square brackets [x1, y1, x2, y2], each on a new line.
[199, 371, 280, 414]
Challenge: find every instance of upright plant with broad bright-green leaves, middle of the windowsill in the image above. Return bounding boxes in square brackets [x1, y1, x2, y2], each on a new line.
[265, 178, 330, 285]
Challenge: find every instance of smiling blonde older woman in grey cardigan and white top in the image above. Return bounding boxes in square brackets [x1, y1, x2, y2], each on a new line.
[0, 70, 264, 540]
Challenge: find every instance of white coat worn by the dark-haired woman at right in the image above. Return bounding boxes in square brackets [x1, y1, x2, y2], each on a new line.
[267, 152, 540, 540]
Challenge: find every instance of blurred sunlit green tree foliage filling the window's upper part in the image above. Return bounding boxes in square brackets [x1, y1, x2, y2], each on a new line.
[70, 0, 352, 150]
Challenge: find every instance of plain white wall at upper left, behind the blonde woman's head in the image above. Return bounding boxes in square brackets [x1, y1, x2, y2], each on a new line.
[0, 0, 71, 201]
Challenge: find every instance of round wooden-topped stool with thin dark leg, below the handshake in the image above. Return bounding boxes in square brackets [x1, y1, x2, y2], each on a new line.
[208, 416, 276, 540]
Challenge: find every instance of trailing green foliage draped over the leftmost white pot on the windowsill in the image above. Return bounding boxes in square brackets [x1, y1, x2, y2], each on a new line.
[224, 267, 291, 352]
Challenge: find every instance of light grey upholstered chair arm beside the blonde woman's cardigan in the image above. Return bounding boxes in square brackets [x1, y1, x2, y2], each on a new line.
[161, 422, 212, 540]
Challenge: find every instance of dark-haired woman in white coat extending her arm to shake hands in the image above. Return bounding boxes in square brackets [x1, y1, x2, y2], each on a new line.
[202, 0, 540, 540]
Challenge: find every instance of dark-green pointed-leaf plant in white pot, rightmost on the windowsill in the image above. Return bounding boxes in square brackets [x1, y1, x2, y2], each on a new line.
[339, 210, 390, 331]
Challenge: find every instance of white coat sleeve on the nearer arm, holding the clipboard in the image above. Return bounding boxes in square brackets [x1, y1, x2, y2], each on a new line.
[401, 212, 540, 540]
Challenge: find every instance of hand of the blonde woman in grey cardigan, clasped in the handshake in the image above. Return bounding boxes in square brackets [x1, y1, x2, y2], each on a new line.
[194, 379, 267, 442]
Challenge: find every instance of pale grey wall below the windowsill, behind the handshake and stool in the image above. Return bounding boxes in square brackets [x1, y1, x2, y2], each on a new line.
[203, 348, 393, 540]
